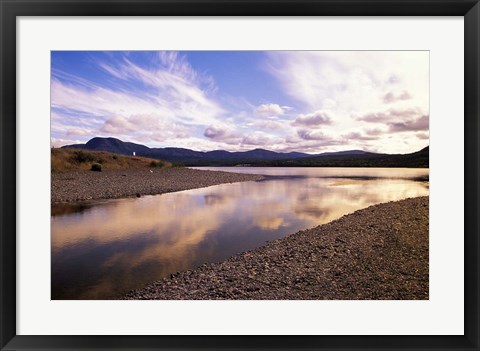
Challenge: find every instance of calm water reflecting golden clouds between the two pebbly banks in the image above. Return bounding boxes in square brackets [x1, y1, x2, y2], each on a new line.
[51, 167, 429, 299]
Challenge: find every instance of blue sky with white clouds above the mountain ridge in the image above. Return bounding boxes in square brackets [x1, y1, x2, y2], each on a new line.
[51, 51, 429, 154]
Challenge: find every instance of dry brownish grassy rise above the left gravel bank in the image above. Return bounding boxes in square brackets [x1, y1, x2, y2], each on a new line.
[51, 148, 172, 173]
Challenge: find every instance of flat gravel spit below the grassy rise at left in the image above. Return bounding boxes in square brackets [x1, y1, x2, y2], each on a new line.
[51, 168, 263, 204]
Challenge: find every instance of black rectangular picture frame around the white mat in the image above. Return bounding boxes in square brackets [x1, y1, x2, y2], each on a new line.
[0, 0, 480, 350]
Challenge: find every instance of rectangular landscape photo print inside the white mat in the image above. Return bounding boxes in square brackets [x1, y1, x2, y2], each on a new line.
[50, 51, 430, 300]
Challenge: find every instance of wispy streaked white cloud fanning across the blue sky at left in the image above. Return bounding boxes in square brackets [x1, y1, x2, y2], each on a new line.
[51, 53, 225, 147]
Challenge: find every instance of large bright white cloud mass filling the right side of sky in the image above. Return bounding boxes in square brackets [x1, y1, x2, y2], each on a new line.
[265, 51, 429, 152]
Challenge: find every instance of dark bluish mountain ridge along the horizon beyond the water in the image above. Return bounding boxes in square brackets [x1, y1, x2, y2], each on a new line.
[63, 137, 428, 167]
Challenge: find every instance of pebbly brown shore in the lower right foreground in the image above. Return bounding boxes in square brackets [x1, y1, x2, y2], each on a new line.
[124, 197, 429, 300]
